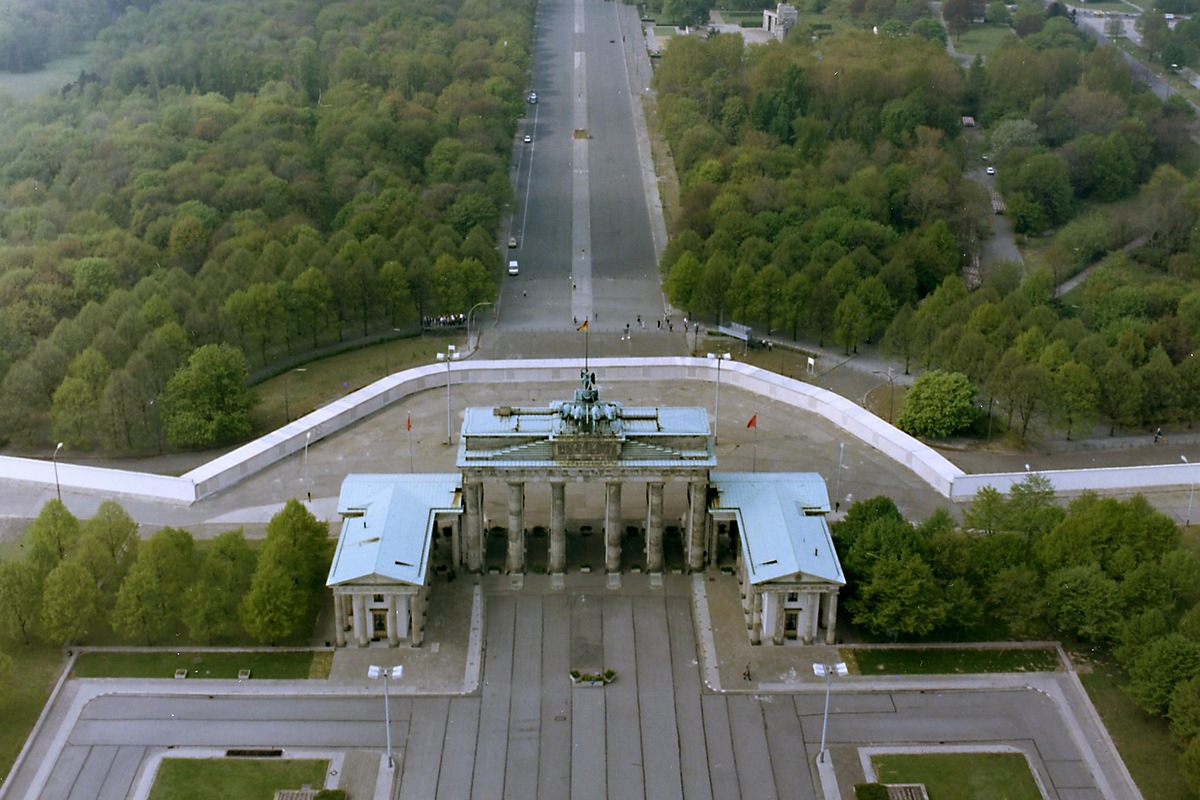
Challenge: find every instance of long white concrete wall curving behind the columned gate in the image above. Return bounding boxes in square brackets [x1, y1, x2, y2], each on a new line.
[0, 357, 1200, 504]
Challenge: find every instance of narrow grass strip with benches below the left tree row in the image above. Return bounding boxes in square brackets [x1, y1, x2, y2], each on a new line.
[72, 651, 312, 680]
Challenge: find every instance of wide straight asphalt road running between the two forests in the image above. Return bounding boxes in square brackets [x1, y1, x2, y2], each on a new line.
[481, 0, 683, 357]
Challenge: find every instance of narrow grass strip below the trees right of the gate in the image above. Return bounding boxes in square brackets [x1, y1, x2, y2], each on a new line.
[852, 648, 1058, 675]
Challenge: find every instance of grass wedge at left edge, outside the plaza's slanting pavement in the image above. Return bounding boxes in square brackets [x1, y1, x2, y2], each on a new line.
[0, 638, 62, 781]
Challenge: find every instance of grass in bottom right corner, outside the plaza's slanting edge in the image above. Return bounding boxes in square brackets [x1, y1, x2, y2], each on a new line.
[1079, 660, 1196, 800]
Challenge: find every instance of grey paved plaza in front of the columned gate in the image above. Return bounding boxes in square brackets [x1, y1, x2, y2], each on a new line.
[7, 573, 1135, 800]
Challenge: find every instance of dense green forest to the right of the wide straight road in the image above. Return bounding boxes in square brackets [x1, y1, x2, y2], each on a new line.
[655, 4, 1200, 439]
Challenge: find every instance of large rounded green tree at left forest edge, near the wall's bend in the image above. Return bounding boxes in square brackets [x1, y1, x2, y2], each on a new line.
[162, 344, 256, 446]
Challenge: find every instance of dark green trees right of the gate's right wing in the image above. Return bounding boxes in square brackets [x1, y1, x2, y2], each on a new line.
[833, 475, 1200, 790]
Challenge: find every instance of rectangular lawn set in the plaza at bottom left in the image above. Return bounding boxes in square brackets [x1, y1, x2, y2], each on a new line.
[150, 758, 329, 800]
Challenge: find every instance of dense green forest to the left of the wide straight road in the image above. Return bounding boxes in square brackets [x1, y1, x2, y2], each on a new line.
[0, 0, 534, 451]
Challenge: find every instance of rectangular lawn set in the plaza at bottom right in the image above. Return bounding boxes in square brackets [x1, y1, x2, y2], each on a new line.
[871, 753, 1042, 800]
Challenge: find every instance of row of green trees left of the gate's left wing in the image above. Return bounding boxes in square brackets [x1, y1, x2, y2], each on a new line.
[0, 500, 332, 645]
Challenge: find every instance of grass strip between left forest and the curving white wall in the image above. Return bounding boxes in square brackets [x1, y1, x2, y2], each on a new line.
[250, 328, 460, 437]
